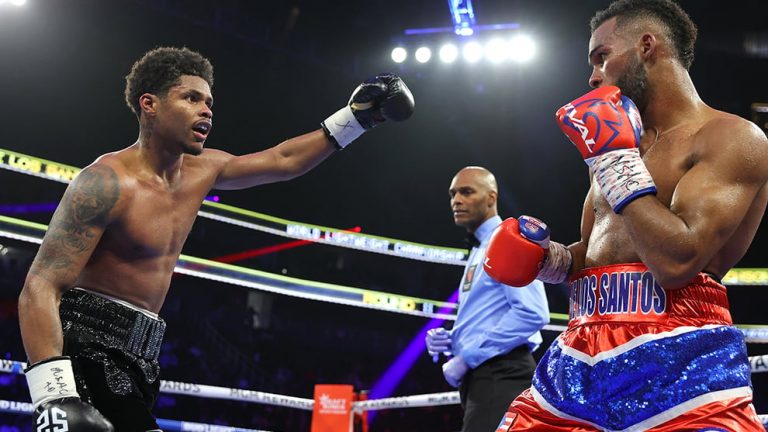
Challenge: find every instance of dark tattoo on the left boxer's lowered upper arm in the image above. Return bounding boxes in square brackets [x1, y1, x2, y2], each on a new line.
[30, 165, 120, 282]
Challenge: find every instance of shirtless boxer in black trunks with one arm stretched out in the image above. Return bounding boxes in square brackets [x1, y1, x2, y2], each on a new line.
[19, 48, 413, 432]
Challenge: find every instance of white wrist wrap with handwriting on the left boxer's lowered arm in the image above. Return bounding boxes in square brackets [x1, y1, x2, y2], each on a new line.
[24, 357, 80, 409]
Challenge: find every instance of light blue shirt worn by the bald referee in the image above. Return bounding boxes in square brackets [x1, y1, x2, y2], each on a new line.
[451, 216, 549, 369]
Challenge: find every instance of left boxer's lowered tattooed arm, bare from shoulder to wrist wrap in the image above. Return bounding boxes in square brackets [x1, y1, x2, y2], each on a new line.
[19, 164, 120, 363]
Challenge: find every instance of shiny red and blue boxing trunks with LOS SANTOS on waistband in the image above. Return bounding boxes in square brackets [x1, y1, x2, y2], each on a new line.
[497, 263, 765, 432]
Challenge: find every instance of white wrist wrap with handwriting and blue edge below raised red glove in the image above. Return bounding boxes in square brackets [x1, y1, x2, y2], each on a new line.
[590, 148, 656, 213]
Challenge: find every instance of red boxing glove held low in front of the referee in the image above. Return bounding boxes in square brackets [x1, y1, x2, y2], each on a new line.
[483, 216, 549, 287]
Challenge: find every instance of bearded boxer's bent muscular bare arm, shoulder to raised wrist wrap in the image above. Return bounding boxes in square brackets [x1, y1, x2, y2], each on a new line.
[622, 116, 768, 289]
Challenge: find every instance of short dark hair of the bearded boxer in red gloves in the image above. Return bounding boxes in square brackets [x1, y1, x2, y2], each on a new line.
[589, 0, 698, 69]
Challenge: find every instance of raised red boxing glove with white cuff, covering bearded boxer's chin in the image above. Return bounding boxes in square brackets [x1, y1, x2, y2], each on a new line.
[555, 86, 656, 213]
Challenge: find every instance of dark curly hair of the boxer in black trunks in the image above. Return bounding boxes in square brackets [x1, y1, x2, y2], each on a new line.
[125, 47, 213, 117]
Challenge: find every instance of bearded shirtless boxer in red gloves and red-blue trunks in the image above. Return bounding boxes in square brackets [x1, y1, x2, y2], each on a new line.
[485, 0, 768, 432]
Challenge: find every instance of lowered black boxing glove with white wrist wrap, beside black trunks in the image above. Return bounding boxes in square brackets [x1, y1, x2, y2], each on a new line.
[24, 356, 115, 432]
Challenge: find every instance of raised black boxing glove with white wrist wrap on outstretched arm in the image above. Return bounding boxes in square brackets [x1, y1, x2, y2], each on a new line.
[321, 74, 414, 150]
